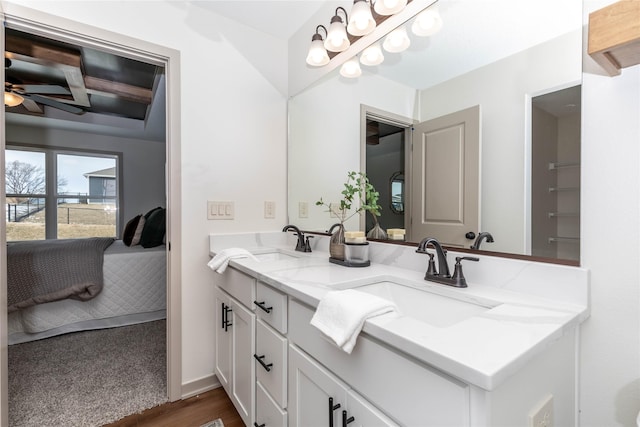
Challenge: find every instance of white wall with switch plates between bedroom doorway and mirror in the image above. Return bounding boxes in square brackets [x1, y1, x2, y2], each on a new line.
[3, 1, 287, 384]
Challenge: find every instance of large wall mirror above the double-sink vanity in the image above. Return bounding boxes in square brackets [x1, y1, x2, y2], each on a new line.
[288, 0, 582, 261]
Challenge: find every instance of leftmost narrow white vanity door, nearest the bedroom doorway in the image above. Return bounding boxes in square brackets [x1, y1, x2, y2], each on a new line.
[214, 288, 232, 394]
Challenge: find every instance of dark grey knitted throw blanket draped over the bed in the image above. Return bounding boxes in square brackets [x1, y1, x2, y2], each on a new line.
[7, 237, 114, 312]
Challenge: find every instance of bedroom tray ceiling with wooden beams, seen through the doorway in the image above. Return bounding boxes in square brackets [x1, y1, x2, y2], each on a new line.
[5, 29, 165, 141]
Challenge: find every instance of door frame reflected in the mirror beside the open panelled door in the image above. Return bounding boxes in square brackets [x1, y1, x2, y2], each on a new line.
[360, 104, 418, 236]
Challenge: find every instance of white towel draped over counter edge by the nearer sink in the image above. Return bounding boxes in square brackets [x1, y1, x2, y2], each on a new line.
[311, 289, 397, 354]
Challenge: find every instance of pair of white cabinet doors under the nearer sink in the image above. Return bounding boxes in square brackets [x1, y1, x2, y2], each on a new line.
[289, 345, 397, 427]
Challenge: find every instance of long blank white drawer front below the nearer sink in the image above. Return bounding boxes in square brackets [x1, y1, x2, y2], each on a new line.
[288, 300, 470, 427]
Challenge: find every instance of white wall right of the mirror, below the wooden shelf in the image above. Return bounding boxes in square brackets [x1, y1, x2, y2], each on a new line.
[580, 0, 640, 427]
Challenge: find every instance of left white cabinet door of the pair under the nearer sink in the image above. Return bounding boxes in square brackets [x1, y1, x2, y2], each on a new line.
[288, 346, 347, 427]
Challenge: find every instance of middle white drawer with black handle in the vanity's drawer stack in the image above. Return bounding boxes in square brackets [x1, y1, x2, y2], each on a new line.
[256, 320, 287, 408]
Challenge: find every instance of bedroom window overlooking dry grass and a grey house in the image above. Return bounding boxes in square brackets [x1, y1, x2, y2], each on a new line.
[5, 147, 120, 241]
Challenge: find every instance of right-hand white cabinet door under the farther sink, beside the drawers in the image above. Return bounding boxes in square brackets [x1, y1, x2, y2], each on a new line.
[229, 298, 256, 425]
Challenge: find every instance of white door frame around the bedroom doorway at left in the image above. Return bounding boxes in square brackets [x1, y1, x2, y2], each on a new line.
[0, 3, 182, 425]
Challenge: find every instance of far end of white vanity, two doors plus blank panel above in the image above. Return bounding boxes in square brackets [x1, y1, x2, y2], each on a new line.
[214, 269, 256, 425]
